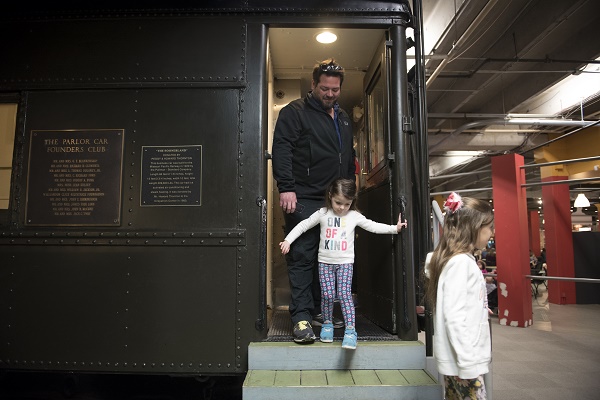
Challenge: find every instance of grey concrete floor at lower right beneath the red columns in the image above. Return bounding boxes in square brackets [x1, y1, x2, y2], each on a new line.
[492, 287, 600, 400]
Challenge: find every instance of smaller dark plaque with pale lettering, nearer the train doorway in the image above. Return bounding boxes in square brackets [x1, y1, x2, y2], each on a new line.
[140, 145, 202, 206]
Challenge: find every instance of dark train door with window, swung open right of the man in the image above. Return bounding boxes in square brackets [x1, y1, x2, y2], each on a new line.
[354, 36, 395, 331]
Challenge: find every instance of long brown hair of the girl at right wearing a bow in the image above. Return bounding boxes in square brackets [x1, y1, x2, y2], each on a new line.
[425, 197, 494, 311]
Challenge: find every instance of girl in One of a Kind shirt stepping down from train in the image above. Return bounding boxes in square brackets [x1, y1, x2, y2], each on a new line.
[279, 178, 407, 349]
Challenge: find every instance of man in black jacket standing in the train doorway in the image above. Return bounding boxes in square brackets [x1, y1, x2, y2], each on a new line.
[273, 59, 355, 343]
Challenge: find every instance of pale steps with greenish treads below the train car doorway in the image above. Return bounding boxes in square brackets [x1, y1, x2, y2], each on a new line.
[242, 340, 442, 400]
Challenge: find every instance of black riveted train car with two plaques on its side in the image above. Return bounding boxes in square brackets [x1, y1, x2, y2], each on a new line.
[0, 1, 426, 375]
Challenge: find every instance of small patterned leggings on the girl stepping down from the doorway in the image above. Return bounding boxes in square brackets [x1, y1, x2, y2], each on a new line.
[319, 263, 356, 327]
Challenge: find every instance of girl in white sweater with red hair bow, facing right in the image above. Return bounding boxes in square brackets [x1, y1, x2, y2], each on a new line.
[425, 193, 494, 400]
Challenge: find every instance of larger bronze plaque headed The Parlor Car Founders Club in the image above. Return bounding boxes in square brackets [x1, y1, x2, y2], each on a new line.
[25, 129, 125, 226]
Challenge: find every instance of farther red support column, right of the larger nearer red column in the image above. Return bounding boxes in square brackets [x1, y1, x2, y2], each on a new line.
[542, 176, 577, 304]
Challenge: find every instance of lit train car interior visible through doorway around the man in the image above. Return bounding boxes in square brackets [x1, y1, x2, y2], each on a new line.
[267, 27, 386, 309]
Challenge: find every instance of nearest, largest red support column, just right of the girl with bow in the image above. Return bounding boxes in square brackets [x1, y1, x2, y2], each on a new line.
[492, 154, 533, 327]
